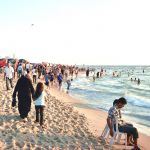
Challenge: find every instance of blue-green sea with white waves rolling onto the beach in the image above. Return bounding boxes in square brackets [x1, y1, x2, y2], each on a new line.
[63, 66, 150, 136]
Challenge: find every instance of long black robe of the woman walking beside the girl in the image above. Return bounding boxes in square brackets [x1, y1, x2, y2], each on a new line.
[13, 76, 34, 119]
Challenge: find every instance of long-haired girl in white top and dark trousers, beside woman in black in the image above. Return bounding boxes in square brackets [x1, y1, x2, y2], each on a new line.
[34, 82, 45, 126]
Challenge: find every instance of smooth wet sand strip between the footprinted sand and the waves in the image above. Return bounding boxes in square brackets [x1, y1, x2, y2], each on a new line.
[50, 87, 150, 150]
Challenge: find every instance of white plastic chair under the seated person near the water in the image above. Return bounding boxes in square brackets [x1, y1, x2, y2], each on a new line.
[101, 118, 127, 149]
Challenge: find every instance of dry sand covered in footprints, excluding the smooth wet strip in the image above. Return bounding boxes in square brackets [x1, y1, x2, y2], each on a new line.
[0, 75, 104, 150]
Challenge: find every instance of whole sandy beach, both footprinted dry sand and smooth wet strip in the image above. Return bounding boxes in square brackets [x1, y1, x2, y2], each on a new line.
[0, 75, 150, 150]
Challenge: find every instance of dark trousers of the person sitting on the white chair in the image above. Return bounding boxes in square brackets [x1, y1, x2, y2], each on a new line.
[118, 124, 139, 139]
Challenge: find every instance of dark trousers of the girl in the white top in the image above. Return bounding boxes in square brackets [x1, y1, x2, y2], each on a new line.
[35, 106, 44, 125]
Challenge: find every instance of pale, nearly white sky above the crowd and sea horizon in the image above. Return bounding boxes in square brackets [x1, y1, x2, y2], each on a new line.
[0, 0, 150, 65]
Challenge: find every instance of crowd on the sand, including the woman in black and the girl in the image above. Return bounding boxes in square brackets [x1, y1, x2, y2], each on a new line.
[4, 62, 78, 126]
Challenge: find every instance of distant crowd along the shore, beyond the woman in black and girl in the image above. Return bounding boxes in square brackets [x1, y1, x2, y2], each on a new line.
[4, 62, 79, 90]
